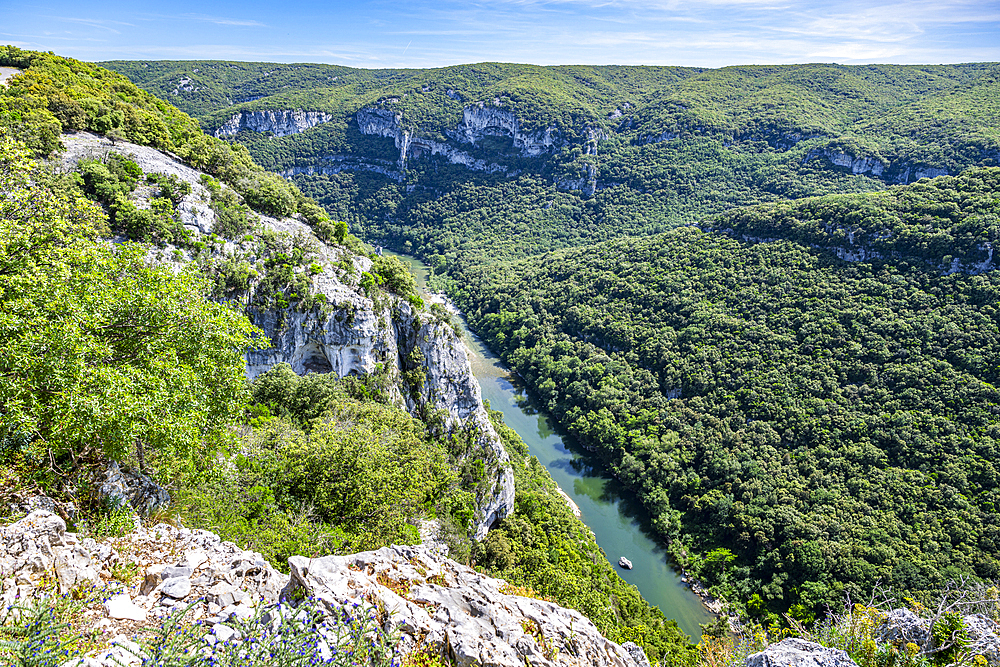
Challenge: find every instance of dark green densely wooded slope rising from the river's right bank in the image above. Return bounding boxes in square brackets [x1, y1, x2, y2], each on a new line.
[450, 168, 1000, 619]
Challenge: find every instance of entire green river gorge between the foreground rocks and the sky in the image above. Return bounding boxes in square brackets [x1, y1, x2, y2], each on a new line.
[0, 47, 1000, 667]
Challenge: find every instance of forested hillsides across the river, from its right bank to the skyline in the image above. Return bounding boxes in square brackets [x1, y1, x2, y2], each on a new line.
[97, 56, 1000, 622]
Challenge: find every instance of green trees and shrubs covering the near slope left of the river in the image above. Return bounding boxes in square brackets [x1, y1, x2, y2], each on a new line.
[0, 47, 696, 665]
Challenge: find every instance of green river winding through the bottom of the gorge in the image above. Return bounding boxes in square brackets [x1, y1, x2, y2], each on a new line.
[385, 252, 714, 640]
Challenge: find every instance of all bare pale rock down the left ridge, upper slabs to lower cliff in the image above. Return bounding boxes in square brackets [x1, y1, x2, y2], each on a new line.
[53, 133, 514, 539]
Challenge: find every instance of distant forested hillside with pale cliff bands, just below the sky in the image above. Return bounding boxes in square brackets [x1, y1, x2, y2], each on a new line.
[108, 61, 1000, 273]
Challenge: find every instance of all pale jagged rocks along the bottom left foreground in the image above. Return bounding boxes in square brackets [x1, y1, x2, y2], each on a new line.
[0, 510, 648, 667]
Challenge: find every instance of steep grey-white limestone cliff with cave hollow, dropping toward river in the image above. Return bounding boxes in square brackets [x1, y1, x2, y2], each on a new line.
[247, 290, 514, 539]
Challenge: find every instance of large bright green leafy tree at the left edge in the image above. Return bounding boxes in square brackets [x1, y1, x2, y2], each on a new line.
[0, 137, 255, 474]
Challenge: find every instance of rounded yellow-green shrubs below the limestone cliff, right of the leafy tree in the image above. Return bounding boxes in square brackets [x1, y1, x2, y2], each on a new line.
[177, 364, 456, 568]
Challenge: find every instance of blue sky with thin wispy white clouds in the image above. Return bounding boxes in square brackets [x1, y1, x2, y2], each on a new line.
[0, 0, 1000, 67]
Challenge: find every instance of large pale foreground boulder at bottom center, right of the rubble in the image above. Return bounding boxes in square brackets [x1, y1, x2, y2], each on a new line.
[284, 546, 637, 667]
